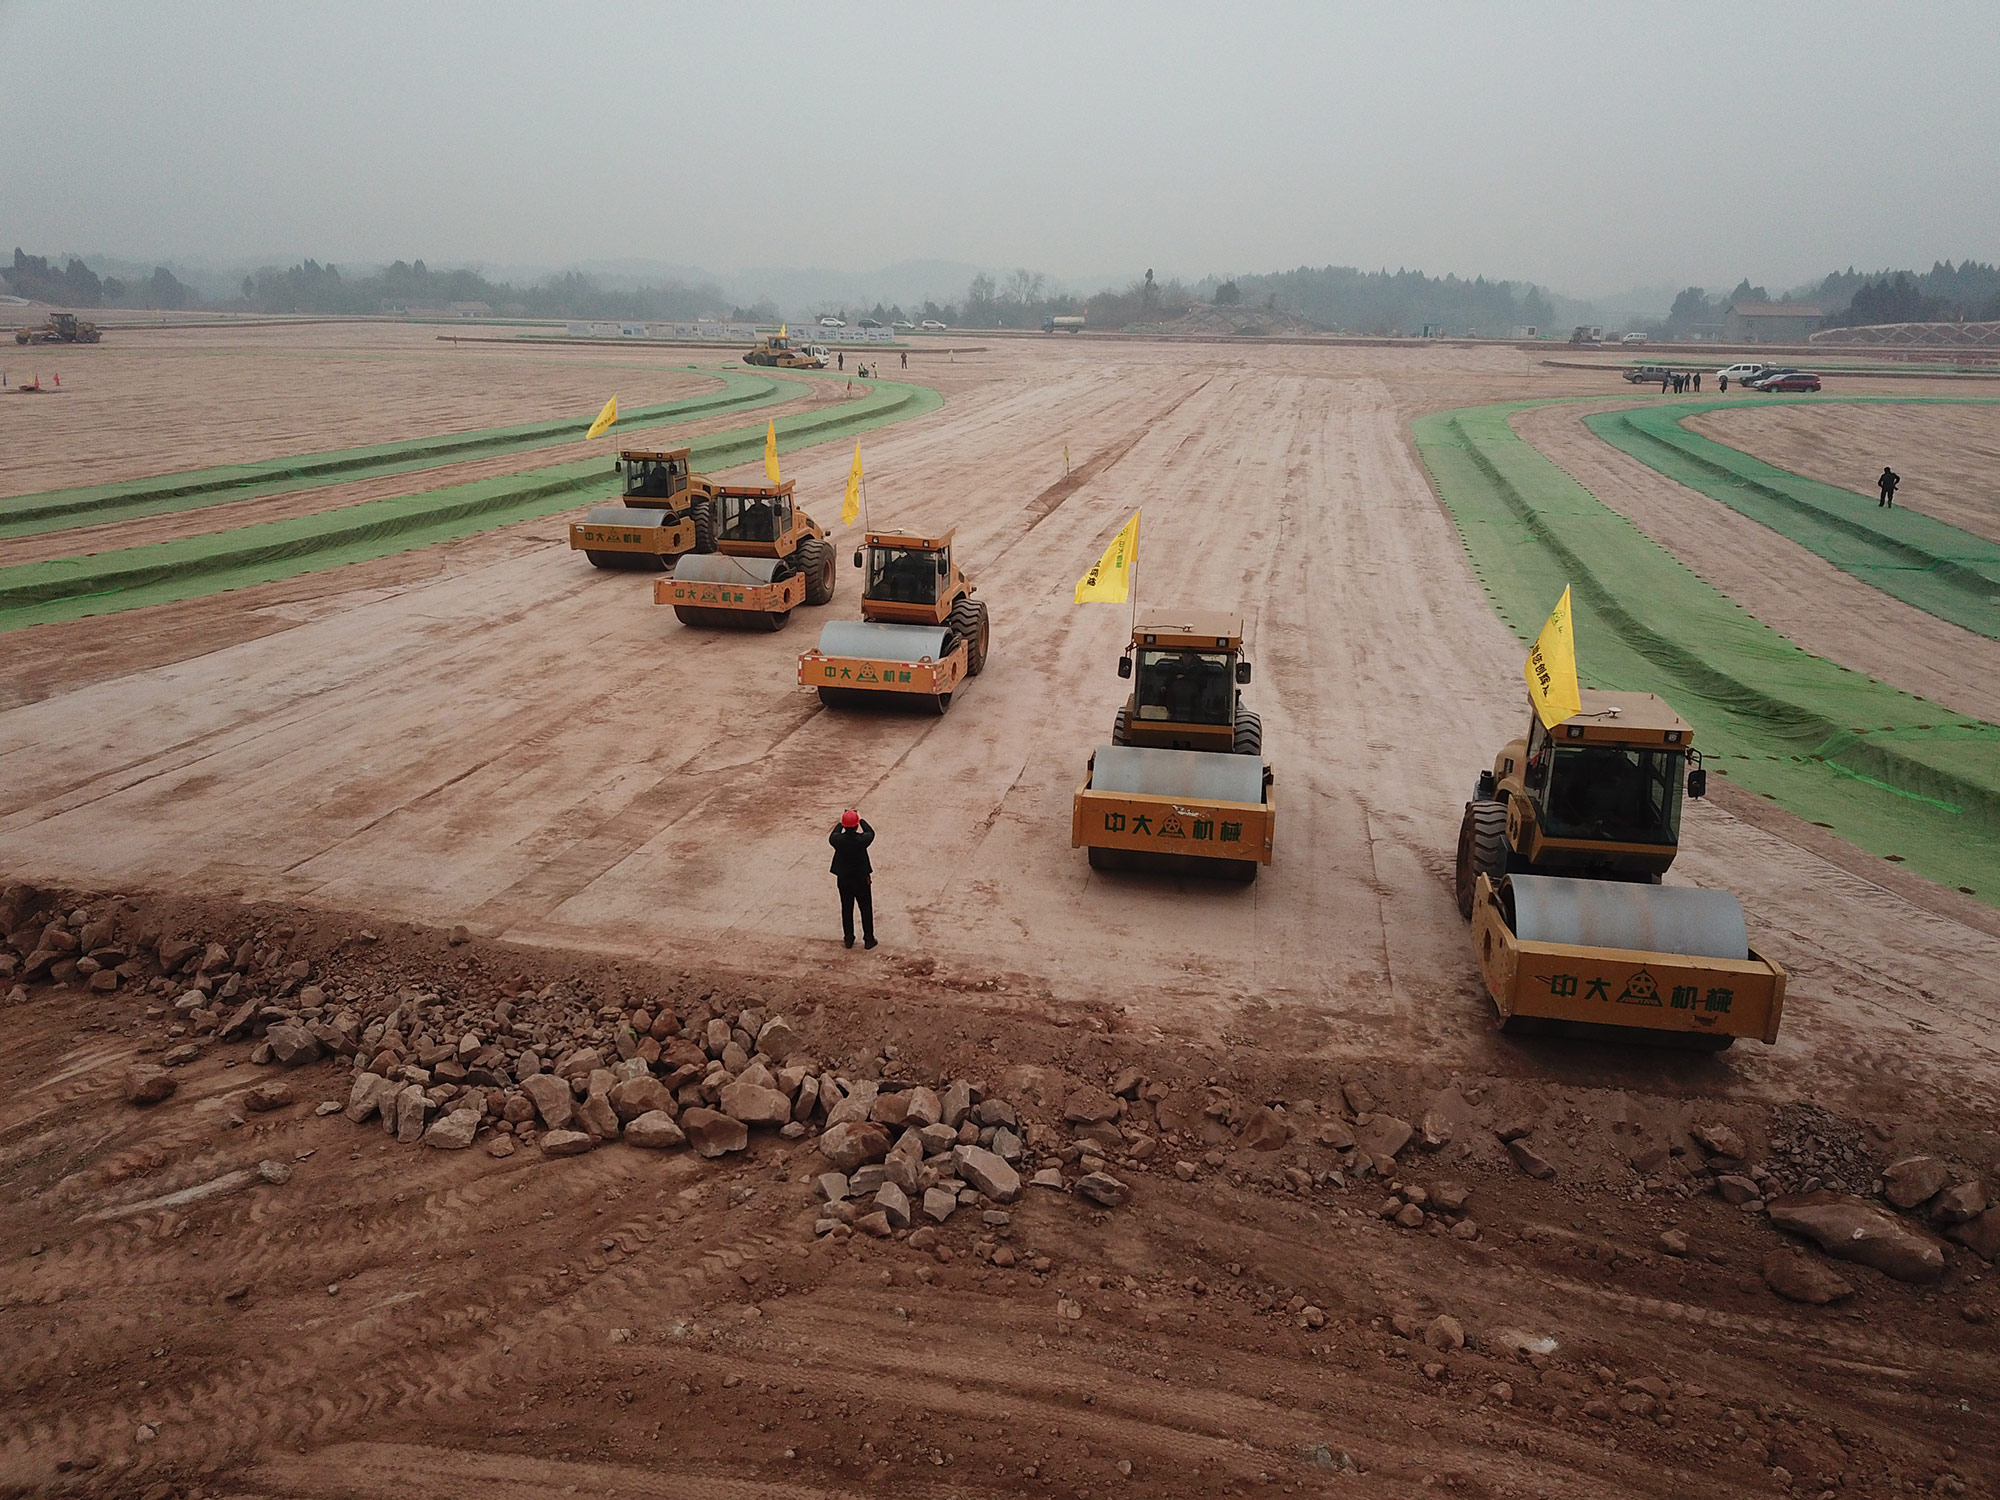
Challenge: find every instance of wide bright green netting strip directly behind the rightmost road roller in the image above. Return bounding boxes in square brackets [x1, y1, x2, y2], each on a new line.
[1414, 402, 2000, 904]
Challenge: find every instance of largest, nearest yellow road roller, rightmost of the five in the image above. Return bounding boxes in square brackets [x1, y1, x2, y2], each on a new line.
[1456, 688, 1784, 1052]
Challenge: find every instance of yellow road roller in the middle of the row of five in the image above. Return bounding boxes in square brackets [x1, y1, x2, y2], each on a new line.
[798, 532, 992, 714]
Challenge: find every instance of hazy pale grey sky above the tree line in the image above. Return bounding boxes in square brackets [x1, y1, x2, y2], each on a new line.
[0, 0, 2000, 294]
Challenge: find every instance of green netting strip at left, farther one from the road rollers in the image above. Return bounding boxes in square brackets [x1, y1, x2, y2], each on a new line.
[0, 366, 800, 536]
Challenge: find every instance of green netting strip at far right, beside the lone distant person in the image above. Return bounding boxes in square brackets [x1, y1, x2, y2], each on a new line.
[1584, 398, 2000, 640]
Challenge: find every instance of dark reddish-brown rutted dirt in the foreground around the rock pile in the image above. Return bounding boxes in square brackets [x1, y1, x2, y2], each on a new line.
[0, 890, 2000, 1498]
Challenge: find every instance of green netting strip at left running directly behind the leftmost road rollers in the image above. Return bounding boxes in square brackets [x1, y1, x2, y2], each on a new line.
[0, 380, 944, 630]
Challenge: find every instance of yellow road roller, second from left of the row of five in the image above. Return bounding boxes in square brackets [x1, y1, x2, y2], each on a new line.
[652, 480, 836, 630]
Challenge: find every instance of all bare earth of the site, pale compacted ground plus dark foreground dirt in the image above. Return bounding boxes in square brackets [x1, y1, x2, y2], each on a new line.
[0, 326, 2000, 1498]
